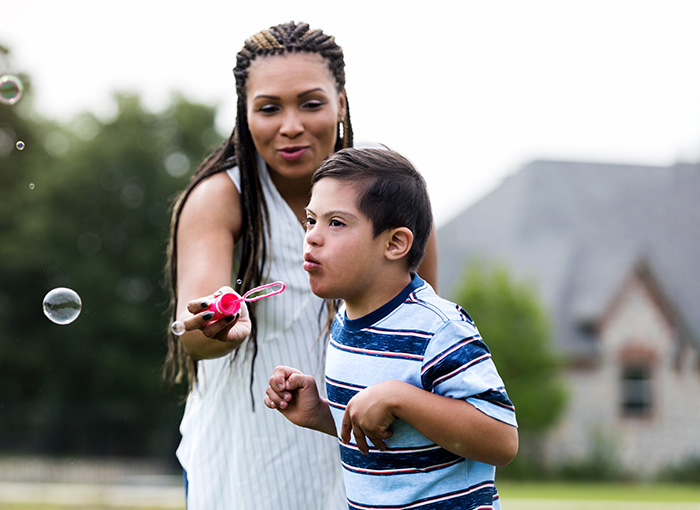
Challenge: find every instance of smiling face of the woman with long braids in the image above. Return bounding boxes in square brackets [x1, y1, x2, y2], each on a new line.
[246, 53, 345, 180]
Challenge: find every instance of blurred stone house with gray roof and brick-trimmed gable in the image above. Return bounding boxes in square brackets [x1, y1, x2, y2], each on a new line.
[438, 161, 700, 478]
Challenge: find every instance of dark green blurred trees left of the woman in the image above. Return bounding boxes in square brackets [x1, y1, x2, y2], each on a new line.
[0, 84, 221, 455]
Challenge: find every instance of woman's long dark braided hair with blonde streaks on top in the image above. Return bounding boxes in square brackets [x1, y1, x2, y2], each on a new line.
[163, 21, 353, 397]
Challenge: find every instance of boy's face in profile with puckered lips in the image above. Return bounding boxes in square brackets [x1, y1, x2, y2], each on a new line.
[304, 178, 386, 304]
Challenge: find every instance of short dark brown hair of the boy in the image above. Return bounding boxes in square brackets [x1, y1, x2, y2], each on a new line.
[312, 148, 433, 271]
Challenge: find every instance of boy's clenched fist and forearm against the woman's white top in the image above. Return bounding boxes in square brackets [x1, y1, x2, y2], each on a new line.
[265, 366, 337, 437]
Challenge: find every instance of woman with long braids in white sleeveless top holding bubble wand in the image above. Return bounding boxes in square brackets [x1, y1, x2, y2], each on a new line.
[166, 22, 437, 510]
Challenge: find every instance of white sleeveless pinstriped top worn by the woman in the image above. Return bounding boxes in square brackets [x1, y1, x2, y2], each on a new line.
[177, 158, 347, 510]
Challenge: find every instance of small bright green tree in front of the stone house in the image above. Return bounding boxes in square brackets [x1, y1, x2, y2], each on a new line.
[456, 261, 567, 474]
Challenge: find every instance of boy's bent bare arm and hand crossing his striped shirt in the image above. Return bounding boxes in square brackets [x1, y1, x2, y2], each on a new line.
[340, 381, 518, 466]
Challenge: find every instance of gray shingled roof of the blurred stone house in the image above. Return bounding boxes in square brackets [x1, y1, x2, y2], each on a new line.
[438, 161, 700, 355]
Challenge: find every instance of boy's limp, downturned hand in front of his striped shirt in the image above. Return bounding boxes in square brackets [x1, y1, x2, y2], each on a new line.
[340, 381, 405, 453]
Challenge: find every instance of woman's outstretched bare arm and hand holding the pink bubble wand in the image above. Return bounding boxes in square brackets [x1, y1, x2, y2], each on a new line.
[176, 172, 245, 359]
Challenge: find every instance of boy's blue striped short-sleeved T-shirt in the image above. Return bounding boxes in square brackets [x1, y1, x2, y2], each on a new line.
[326, 275, 517, 510]
